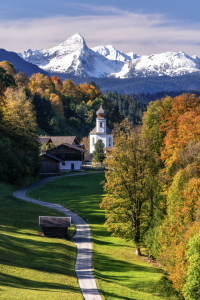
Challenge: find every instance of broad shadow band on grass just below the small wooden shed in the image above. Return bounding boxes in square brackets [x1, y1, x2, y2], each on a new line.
[0, 234, 75, 277]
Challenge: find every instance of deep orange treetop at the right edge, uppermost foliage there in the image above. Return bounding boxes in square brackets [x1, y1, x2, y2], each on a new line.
[160, 94, 200, 176]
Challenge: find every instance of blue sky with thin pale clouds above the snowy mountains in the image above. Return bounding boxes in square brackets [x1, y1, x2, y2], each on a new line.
[0, 0, 200, 56]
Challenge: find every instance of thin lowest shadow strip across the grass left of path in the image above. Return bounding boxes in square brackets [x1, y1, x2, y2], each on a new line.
[0, 273, 80, 293]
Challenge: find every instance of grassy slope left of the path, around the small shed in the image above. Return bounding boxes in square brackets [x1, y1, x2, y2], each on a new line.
[0, 183, 83, 300]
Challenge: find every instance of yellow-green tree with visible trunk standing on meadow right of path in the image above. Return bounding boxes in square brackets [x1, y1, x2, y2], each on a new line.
[100, 121, 157, 255]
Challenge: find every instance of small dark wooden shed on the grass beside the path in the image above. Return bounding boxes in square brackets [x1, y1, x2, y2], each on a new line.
[39, 216, 71, 238]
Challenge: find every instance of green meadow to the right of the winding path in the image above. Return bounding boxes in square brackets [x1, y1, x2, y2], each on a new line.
[26, 174, 165, 300]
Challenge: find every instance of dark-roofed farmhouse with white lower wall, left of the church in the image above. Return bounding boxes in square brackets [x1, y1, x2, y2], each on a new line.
[40, 143, 86, 173]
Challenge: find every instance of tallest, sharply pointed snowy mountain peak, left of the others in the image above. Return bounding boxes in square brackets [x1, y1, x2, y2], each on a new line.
[18, 33, 123, 77]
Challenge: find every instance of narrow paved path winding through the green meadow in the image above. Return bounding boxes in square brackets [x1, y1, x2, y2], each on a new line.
[13, 172, 102, 300]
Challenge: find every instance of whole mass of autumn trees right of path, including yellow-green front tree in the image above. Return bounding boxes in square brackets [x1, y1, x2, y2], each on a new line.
[101, 94, 200, 300]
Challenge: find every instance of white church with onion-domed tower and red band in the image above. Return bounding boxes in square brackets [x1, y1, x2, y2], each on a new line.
[90, 104, 113, 153]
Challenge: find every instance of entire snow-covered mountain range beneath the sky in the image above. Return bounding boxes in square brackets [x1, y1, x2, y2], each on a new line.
[18, 33, 200, 79]
